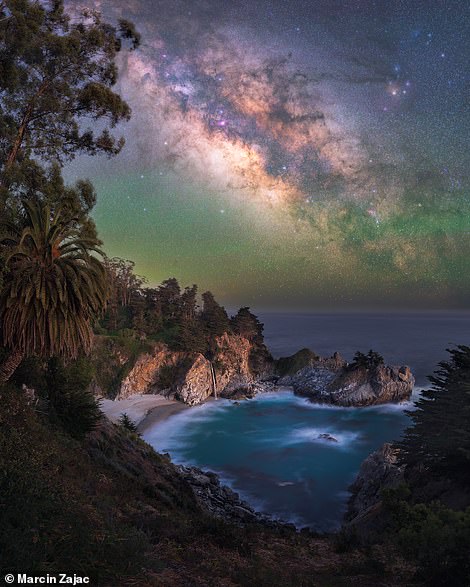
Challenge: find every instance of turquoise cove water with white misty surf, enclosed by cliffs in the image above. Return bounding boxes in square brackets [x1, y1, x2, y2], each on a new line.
[145, 390, 411, 530]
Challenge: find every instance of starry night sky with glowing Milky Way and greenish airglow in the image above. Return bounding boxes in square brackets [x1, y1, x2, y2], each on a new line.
[67, 0, 470, 310]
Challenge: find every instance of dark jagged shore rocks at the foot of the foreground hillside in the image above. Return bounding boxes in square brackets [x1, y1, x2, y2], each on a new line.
[176, 465, 295, 529]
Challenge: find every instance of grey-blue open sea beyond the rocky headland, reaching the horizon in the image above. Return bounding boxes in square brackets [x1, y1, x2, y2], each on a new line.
[259, 312, 470, 385]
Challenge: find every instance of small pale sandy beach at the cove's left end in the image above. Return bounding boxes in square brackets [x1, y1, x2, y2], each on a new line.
[100, 394, 189, 432]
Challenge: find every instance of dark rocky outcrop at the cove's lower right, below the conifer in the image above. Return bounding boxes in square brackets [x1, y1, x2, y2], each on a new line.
[344, 443, 404, 537]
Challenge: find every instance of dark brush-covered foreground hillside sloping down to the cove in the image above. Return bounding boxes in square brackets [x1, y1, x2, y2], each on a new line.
[0, 387, 410, 587]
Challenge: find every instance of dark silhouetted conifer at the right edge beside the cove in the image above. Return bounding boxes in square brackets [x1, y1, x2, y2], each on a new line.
[398, 346, 470, 487]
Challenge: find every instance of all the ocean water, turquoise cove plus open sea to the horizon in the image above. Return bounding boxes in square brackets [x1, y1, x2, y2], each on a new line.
[145, 314, 470, 531]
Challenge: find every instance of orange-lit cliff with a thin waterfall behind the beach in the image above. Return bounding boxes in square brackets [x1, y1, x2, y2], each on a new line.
[118, 334, 269, 405]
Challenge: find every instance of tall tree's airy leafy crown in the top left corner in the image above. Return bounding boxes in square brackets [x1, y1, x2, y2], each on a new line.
[0, 0, 139, 179]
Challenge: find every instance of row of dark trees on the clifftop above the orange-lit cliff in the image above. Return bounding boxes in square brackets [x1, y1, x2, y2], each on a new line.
[97, 257, 270, 358]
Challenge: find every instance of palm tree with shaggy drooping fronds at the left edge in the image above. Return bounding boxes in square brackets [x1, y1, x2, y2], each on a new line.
[0, 201, 107, 384]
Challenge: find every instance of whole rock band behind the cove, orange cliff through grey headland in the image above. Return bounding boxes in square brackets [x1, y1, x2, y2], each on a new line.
[94, 333, 415, 407]
